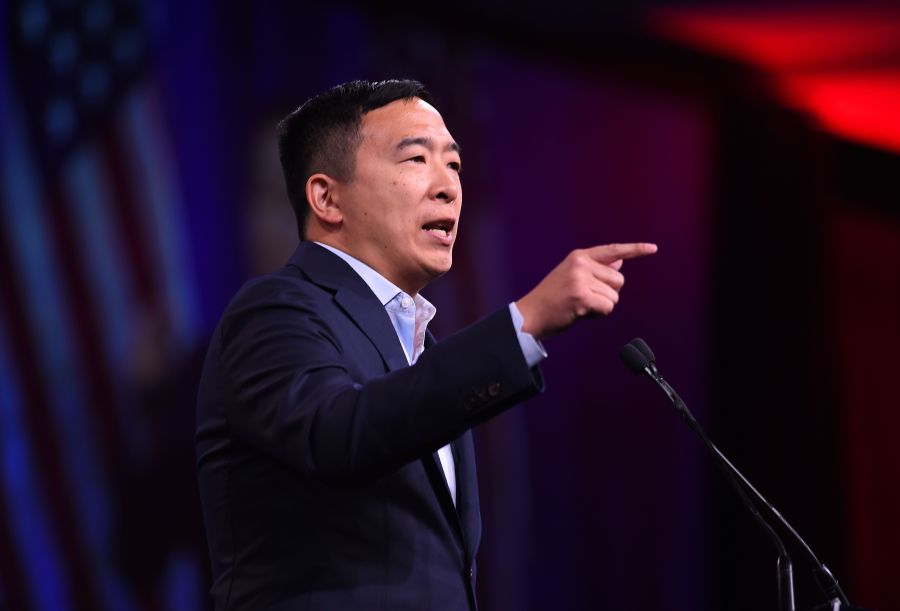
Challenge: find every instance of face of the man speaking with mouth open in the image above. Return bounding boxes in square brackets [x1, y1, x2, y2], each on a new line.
[337, 98, 462, 294]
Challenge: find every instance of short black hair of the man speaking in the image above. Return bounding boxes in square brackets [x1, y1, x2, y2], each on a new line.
[278, 79, 432, 240]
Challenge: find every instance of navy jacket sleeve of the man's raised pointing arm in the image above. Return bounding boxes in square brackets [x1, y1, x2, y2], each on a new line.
[215, 290, 543, 484]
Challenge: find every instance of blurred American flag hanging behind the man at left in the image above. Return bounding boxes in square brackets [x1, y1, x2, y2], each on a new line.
[0, 0, 202, 610]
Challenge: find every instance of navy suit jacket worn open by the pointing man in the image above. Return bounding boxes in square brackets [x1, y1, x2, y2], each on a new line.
[196, 242, 542, 611]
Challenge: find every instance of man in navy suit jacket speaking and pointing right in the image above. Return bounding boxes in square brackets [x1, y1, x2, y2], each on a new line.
[197, 81, 656, 611]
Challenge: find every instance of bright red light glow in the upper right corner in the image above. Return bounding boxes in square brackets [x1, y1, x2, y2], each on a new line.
[650, 8, 900, 152]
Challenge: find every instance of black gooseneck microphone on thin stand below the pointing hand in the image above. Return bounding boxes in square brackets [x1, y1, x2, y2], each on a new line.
[619, 338, 850, 611]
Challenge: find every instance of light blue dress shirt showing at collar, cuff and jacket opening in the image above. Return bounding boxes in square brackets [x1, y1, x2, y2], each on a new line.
[316, 242, 547, 505]
